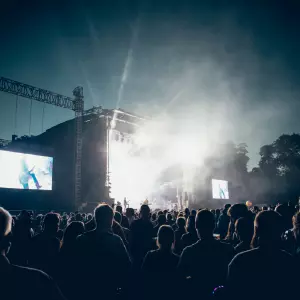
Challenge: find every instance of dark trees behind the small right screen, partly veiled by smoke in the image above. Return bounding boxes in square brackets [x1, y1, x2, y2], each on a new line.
[193, 134, 300, 204]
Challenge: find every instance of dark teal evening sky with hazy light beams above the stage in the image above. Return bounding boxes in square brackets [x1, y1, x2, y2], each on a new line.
[0, 0, 300, 167]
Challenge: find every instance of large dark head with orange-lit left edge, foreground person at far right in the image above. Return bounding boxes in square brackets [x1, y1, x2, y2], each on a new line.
[252, 210, 282, 247]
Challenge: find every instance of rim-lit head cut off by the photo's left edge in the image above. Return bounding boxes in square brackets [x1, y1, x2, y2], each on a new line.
[0, 207, 12, 255]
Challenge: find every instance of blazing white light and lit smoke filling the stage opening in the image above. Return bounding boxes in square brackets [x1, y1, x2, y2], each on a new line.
[109, 120, 210, 208]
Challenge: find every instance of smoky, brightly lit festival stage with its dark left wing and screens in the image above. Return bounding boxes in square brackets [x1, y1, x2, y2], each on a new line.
[0, 108, 238, 210]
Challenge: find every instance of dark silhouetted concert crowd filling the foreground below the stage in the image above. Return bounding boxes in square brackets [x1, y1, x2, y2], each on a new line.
[0, 203, 300, 300]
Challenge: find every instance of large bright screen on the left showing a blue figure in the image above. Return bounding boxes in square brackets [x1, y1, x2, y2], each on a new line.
[0, 150, 53, 191]
